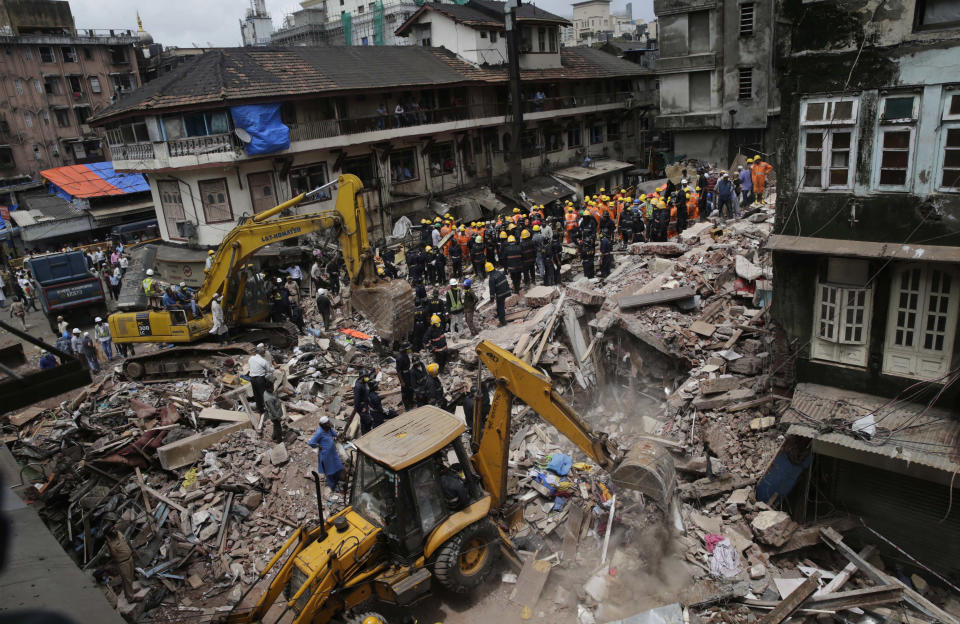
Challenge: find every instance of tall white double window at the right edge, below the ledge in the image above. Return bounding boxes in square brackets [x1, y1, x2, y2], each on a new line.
[882, 263, 960, 379]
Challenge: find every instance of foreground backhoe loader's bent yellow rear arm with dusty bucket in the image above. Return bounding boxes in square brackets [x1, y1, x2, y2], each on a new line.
[473, 340, 676, 509]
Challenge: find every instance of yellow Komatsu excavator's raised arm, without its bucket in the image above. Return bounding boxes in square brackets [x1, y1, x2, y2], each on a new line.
[197, 173, 372, 307]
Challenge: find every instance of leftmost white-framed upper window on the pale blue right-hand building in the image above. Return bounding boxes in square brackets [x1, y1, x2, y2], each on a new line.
[797, 96, 860, 192]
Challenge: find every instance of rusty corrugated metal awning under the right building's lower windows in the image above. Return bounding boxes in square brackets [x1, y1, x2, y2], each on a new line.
[783, 383, 960, 473]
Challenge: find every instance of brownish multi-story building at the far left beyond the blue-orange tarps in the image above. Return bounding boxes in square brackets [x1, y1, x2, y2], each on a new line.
[0, 0, 140, 180]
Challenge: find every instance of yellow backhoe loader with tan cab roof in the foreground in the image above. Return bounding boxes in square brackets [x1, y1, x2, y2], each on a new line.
[222, 341, 675, 624]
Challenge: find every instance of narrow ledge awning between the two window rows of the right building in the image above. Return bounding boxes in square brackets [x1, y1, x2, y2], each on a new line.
[766, 234, 960, 262]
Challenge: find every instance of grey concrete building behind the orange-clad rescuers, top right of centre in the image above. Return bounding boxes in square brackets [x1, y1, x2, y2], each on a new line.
[653, 0, 776, 167]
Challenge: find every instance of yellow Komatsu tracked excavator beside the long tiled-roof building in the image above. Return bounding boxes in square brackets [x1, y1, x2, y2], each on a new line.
[108, 174, 413, 381]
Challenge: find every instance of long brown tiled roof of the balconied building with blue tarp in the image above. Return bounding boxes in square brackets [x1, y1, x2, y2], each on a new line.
[91, 46, 648, 123]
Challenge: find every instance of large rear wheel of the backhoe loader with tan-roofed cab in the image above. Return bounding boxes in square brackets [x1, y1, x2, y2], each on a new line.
[433, 518, 500, 594]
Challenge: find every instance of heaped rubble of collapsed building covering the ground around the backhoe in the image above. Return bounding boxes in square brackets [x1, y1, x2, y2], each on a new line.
[4, 193, 957, 623]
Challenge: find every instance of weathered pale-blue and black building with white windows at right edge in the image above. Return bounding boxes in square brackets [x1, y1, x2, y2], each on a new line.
[768, 0, 960, 581]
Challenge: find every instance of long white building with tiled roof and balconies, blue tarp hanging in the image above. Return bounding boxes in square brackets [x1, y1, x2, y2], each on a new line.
[96, 2, 652, 246]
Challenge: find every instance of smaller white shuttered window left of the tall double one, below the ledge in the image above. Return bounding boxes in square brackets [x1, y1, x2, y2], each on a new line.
[810, 280, 873, 368]
